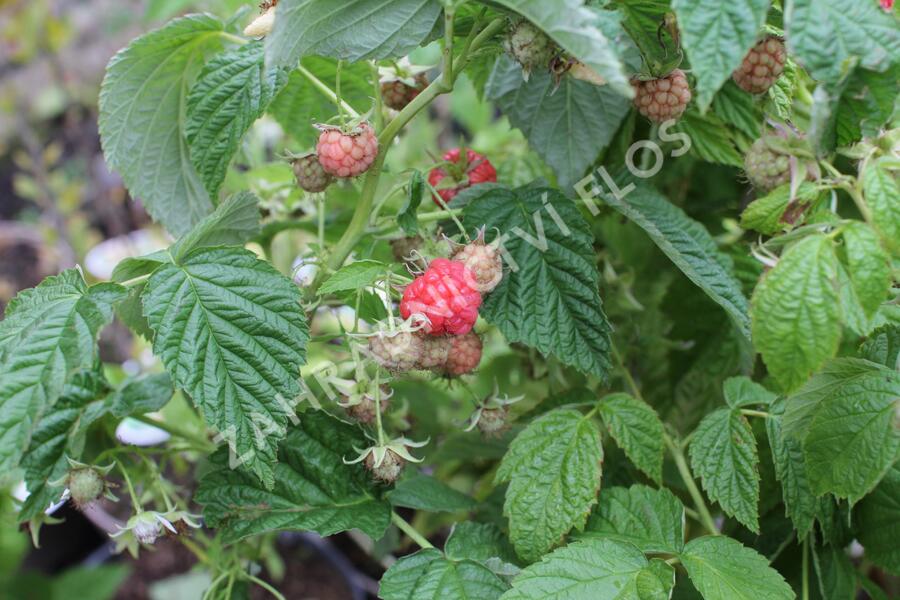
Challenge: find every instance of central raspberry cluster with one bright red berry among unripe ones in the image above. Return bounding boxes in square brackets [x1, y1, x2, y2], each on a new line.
[369, 237, 503, 377]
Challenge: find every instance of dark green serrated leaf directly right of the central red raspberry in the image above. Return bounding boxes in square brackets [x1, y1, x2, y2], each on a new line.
[463, 186, 610, 378]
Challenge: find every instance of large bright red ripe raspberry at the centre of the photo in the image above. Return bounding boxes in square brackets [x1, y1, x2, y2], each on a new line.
[400, 258, 481, 335]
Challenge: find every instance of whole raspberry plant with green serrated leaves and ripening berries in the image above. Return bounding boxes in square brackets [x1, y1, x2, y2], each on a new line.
[0, 0, 900, 600]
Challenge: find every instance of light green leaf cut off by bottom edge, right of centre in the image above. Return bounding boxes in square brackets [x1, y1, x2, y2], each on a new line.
[502, 539, 675, 600]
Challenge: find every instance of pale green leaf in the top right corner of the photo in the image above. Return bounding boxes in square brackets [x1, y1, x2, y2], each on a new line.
[784, 0, 900, 84]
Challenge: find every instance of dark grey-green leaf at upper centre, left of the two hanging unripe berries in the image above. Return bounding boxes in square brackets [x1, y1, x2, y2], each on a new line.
[486, 56, 631, 189]
